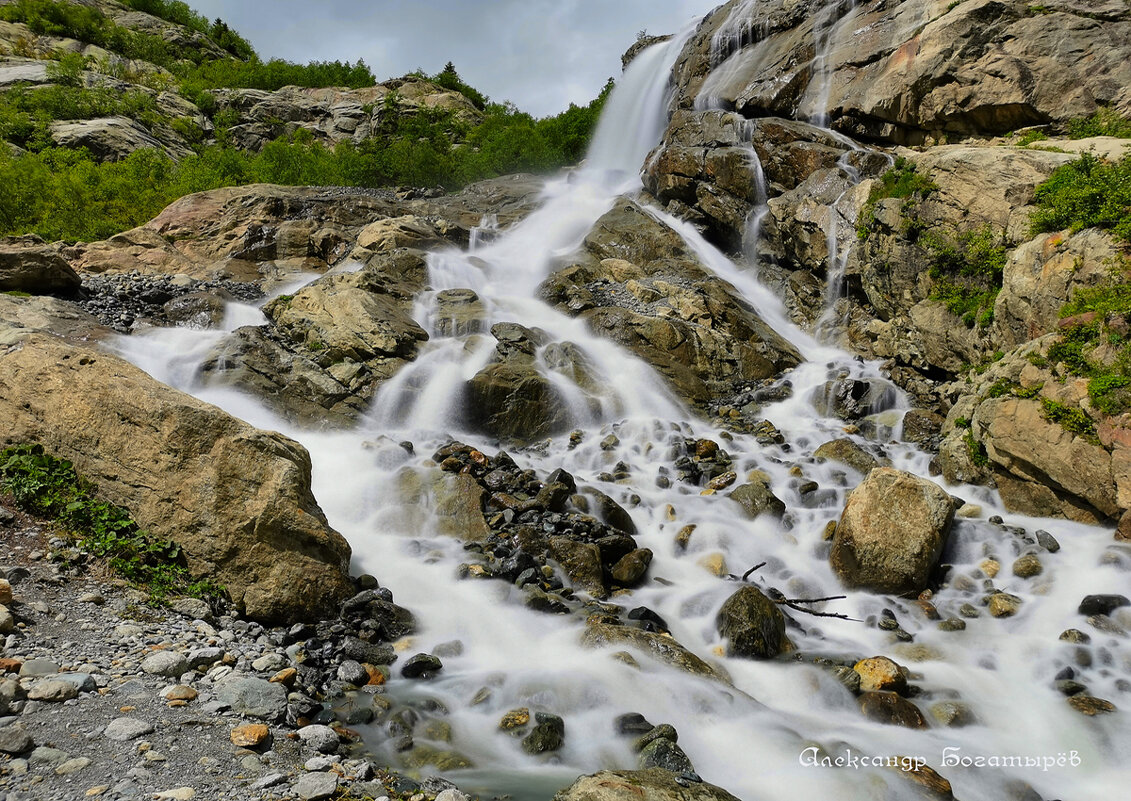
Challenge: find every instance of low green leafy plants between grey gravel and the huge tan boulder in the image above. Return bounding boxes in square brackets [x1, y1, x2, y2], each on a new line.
[0, 445, 224, 601]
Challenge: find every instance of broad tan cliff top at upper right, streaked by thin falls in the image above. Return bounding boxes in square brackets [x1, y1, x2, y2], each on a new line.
[676, 0, 1131, 144]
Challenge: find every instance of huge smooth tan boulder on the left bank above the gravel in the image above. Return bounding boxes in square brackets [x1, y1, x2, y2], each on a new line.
[0, 321, 351, 621]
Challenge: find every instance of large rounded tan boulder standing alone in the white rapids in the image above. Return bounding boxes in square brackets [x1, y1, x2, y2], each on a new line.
[829, 467, 955, 594]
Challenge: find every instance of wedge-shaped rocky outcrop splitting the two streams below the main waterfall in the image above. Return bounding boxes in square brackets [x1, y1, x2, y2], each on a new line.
[541, 200, 801, 403]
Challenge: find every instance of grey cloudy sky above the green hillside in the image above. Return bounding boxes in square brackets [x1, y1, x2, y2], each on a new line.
[188, 0, 722, 117]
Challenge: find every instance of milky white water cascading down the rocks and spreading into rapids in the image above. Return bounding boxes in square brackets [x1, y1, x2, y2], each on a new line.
[106, 15, 1131, 801]
